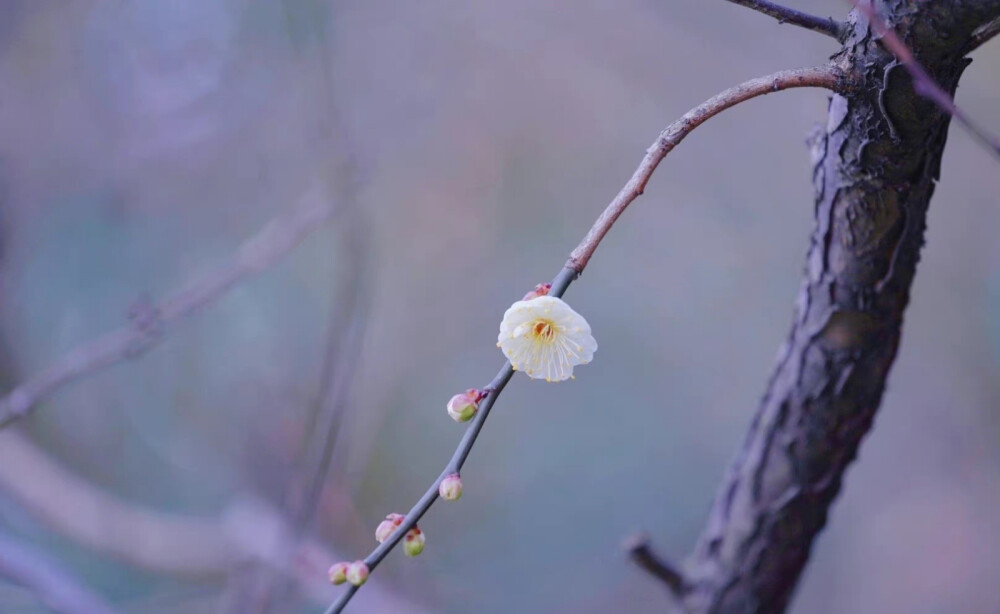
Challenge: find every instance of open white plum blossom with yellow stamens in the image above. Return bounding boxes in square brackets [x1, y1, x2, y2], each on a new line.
[497, 296, 597, 382]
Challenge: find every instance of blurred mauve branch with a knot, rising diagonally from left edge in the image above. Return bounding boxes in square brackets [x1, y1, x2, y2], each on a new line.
[0, 190, 335, 429]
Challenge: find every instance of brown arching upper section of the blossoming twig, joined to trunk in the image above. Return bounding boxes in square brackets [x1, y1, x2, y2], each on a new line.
[566, 66, 853, 273]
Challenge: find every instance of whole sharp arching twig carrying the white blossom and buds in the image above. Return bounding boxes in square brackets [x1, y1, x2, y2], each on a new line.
[324, 66, 851, 614]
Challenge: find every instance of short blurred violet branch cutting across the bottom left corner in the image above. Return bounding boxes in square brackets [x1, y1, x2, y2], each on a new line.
[0, 532, 118, 614]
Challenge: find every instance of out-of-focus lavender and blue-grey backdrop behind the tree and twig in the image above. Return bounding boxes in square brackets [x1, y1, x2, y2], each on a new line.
[0, 0, 1000, 614]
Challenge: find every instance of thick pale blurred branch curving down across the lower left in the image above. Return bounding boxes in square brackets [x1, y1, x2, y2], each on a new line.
[0, 428, 376, 600]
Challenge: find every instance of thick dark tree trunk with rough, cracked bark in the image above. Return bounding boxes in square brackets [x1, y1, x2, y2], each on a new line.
[677, 0, 1000, 613]
